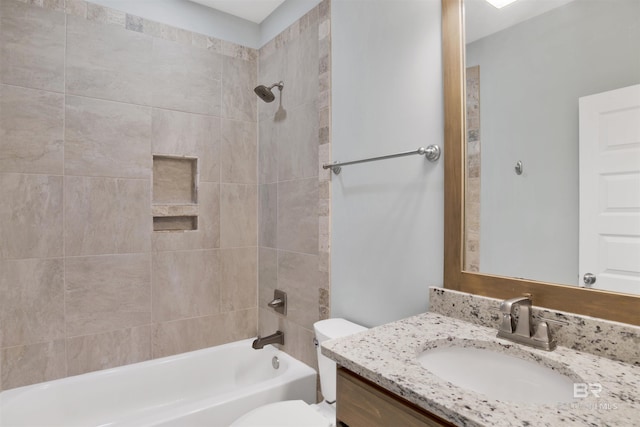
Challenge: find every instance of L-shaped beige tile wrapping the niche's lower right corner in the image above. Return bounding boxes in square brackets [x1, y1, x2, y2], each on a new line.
[151, 182, 220, 251]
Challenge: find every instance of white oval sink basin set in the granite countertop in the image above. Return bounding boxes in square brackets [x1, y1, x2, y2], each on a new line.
[417, 345, 579, 404]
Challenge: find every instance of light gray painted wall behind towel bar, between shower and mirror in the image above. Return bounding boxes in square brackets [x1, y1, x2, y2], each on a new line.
[331, 0, 444, 326]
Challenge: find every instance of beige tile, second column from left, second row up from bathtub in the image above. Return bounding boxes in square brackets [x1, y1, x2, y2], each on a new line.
[65, 254, 151, 337]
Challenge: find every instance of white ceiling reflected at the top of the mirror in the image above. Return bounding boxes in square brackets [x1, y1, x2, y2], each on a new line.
[464, 0, 574, 43]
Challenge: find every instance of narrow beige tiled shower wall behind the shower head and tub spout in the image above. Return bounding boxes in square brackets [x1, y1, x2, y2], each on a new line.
[258, 0, 331, 367]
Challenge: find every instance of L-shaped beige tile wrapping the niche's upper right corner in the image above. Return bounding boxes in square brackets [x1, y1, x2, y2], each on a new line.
[151, 108, 221, 182]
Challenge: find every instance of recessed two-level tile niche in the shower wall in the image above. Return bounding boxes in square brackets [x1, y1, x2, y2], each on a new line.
[151, 155, 198, 231]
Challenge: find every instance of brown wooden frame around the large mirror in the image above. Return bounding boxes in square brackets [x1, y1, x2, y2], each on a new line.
[442, 0, 640, 325]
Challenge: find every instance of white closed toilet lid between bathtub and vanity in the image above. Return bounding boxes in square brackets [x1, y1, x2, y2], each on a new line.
[230, 400, 333, 427]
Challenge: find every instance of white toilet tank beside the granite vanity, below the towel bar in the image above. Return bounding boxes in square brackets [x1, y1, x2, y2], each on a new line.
[313, 319, 367, 402]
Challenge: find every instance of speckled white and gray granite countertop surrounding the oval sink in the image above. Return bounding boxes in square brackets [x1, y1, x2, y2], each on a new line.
[322, 312, 640, 427]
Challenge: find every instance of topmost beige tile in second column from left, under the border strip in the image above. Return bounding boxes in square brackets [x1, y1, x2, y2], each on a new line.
[66, 16, 153, 105]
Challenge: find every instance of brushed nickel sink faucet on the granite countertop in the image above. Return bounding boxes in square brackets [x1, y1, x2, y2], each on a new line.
[498, 296, 556, 351]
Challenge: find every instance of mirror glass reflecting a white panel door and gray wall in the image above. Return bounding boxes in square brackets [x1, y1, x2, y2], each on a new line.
[464, 0, 640, 294]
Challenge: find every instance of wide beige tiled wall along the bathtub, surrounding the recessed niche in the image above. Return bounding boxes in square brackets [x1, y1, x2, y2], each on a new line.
[0, 0, 260, 389]
